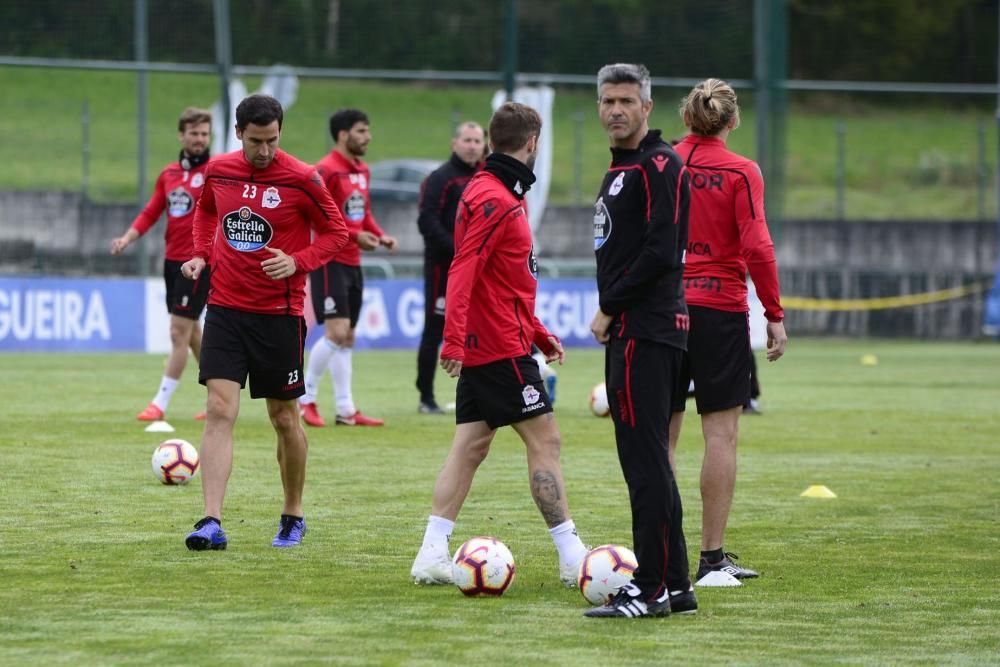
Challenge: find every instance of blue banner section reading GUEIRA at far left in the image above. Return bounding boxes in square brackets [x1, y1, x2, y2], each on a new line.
[0, 277, 146, 352]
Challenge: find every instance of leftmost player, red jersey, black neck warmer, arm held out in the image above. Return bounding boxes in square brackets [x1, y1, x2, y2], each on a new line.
[111, 107, 212, 421]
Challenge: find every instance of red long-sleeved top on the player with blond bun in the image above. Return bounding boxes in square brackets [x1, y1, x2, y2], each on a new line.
[674, 134, 784, 322]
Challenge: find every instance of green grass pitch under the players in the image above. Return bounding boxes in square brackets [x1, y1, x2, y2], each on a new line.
[0, 338, 1000, 665]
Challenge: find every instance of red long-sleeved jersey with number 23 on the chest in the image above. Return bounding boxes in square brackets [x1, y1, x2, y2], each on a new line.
[194, 150, 347, 315]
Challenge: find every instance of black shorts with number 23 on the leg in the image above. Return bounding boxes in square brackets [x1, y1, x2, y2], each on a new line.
[198, 306, 306, 401]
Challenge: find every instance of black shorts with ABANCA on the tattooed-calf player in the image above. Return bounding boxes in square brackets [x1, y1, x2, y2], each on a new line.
[455, 355, 552, 428]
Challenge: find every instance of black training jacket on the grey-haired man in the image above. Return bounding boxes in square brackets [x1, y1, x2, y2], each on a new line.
[594, 130, 689, 349]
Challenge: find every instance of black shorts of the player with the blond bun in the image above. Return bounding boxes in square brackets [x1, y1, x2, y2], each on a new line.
[673, 305, 752, 414]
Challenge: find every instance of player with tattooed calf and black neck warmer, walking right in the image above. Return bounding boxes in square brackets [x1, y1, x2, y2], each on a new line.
[410, 102, 587, 586]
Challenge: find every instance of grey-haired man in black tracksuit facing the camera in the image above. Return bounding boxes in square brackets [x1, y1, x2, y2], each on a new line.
[584, 63, 698, 618]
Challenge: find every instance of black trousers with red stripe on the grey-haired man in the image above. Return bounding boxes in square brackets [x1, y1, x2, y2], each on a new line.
[604, 338, 690, 598]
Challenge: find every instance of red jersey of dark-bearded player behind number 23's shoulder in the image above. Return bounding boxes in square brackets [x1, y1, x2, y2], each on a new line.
[316, 150, 385, 266]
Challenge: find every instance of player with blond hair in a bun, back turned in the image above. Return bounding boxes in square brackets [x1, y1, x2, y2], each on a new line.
[670, 79, 788, 579]
